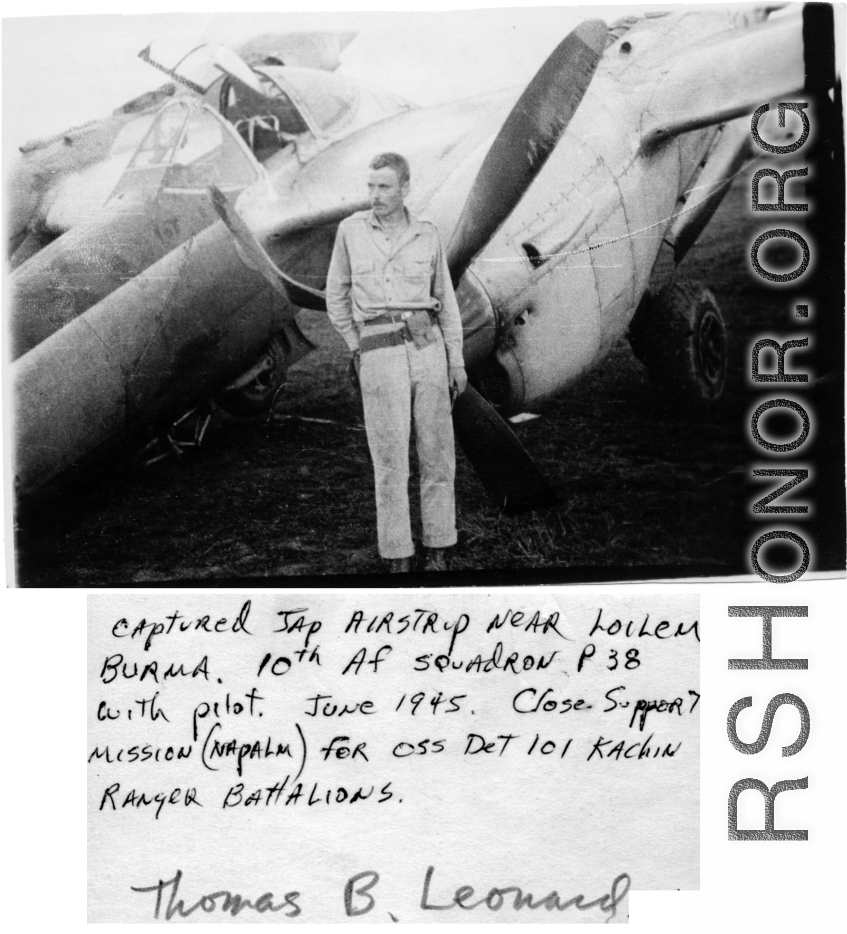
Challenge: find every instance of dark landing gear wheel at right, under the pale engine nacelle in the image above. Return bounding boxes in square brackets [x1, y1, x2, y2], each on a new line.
[628, 282, 727, 405]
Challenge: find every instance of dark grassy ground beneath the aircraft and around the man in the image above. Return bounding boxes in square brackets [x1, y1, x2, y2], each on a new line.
[11, 180, 840, 587]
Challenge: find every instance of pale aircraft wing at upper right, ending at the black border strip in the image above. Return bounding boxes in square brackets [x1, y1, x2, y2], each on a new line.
[641, 16, 805, 154]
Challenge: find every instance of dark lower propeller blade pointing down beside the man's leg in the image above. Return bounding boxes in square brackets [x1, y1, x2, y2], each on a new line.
[453, 386, 560, 513]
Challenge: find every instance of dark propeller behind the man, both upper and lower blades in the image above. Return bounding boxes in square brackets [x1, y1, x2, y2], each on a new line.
[447, 20, 608, 512]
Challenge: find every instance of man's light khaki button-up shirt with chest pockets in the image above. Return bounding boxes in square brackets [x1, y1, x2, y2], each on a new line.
[326, 211, 464, 366]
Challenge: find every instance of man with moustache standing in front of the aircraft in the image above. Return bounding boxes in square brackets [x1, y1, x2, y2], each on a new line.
[326, 152, 467, 573]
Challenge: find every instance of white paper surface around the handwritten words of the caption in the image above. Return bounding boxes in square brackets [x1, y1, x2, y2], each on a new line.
[88, 591, 700, 923]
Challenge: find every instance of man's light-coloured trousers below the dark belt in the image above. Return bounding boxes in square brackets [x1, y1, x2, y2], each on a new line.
[359, 325, 456, 558]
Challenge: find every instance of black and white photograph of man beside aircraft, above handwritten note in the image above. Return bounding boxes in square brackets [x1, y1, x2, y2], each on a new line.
[3, 3, 845, 587]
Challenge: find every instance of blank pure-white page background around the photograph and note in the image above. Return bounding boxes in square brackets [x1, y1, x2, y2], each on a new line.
[0, 0, 847, 934]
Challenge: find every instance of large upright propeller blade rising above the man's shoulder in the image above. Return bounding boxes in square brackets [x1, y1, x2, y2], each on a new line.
[447, 19, 608, 285]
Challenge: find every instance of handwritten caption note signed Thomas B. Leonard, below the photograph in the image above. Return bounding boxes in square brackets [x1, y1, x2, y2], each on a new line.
[87, 593, 700, 923]
